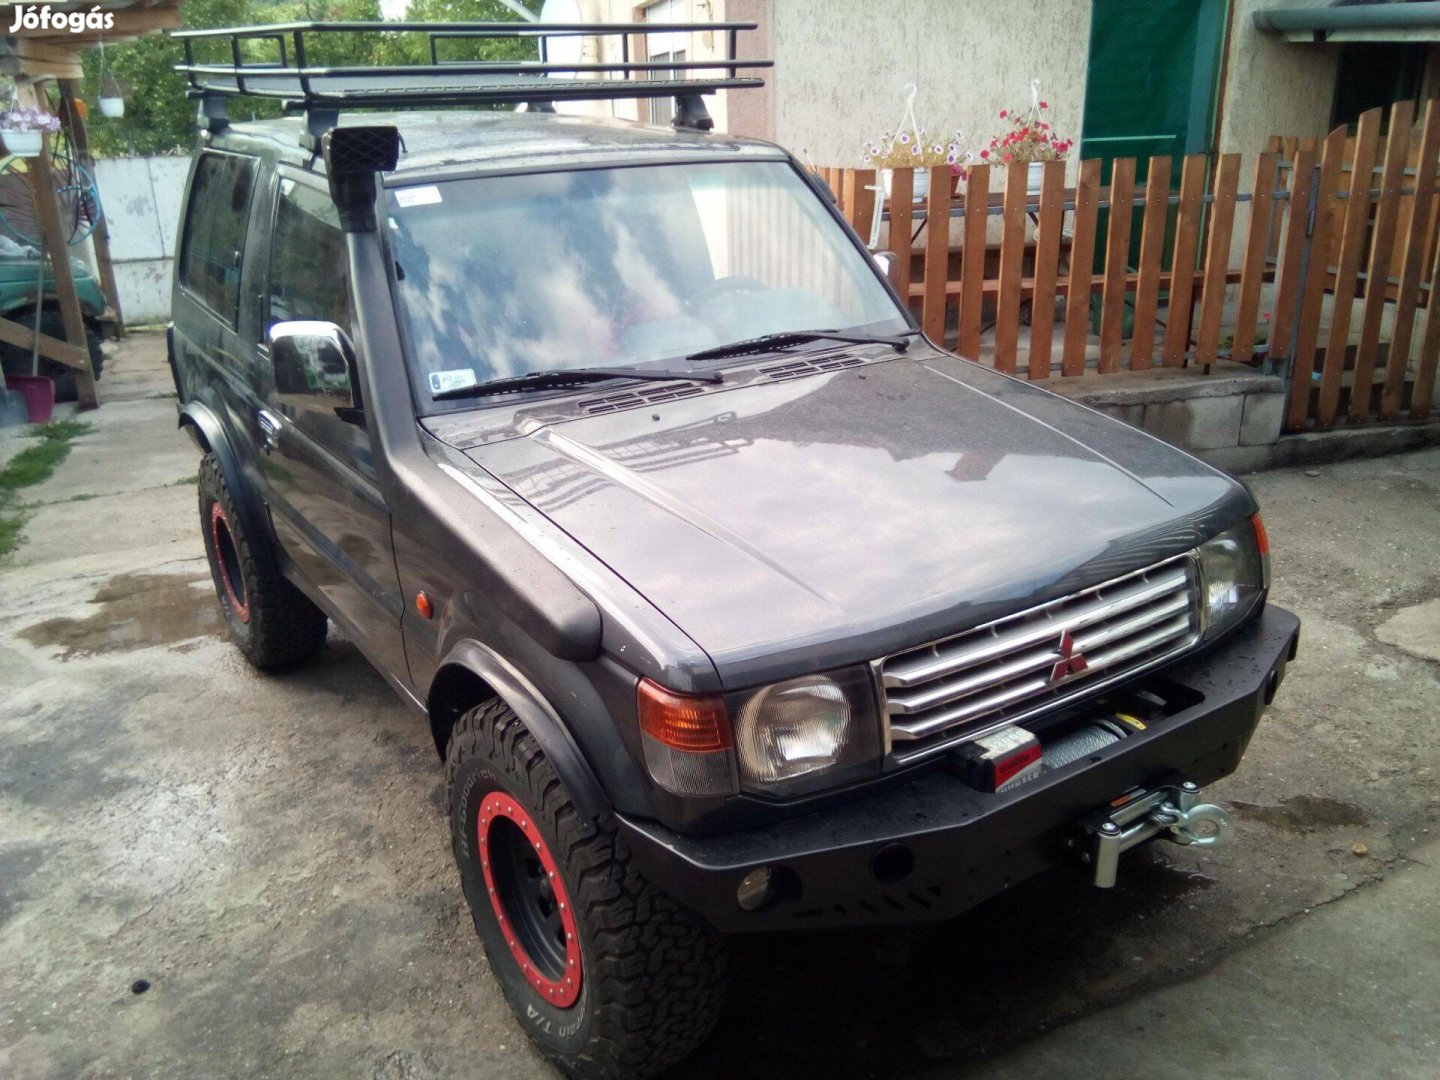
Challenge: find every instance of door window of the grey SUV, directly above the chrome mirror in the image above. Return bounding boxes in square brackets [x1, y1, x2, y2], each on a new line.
[265, 180, 354, 337]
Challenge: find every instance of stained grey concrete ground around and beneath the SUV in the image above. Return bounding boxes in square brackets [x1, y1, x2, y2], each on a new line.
[0, 336, 1440, 1080]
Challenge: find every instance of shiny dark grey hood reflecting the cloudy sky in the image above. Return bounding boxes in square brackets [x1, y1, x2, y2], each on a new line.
[455, 346, 1253, 687]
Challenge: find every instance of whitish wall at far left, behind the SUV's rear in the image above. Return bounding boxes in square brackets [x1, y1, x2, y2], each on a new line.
[95, 157, 190, 325]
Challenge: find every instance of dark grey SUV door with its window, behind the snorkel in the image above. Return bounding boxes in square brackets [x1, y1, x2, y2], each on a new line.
[259, 170, 406, 675]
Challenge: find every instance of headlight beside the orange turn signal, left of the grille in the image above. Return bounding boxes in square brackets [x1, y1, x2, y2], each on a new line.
[727, 667, 880, 796]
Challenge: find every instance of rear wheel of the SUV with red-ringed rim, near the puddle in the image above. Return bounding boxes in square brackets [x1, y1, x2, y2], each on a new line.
[200, 454, 325, 671]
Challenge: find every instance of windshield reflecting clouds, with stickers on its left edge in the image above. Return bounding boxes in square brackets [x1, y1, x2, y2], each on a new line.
[390, 161, 907, 412]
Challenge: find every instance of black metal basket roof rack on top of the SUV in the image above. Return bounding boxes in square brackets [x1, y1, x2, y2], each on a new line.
[173, 22, 773, 135]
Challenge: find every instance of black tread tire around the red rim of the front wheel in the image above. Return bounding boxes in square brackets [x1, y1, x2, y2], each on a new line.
[445, 700, 724, 1080]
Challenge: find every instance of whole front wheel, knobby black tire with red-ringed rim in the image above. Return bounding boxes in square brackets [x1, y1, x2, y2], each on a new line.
[446, 701, 724, 1080]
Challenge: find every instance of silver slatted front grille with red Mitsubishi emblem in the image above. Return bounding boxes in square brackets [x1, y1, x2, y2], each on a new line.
[880, 554, 1201, 763]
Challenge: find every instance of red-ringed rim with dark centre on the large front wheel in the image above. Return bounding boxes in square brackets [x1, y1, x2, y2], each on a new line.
[475, 792, 582, 1008]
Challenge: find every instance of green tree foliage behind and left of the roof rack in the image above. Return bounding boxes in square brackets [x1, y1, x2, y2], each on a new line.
[82, 0, 541, 156]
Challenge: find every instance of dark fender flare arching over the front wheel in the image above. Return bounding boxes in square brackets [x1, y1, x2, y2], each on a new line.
[425, 641, 609, 821]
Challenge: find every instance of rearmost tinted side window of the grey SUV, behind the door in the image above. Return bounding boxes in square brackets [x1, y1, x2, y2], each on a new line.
[180, 153, 255, 327]
